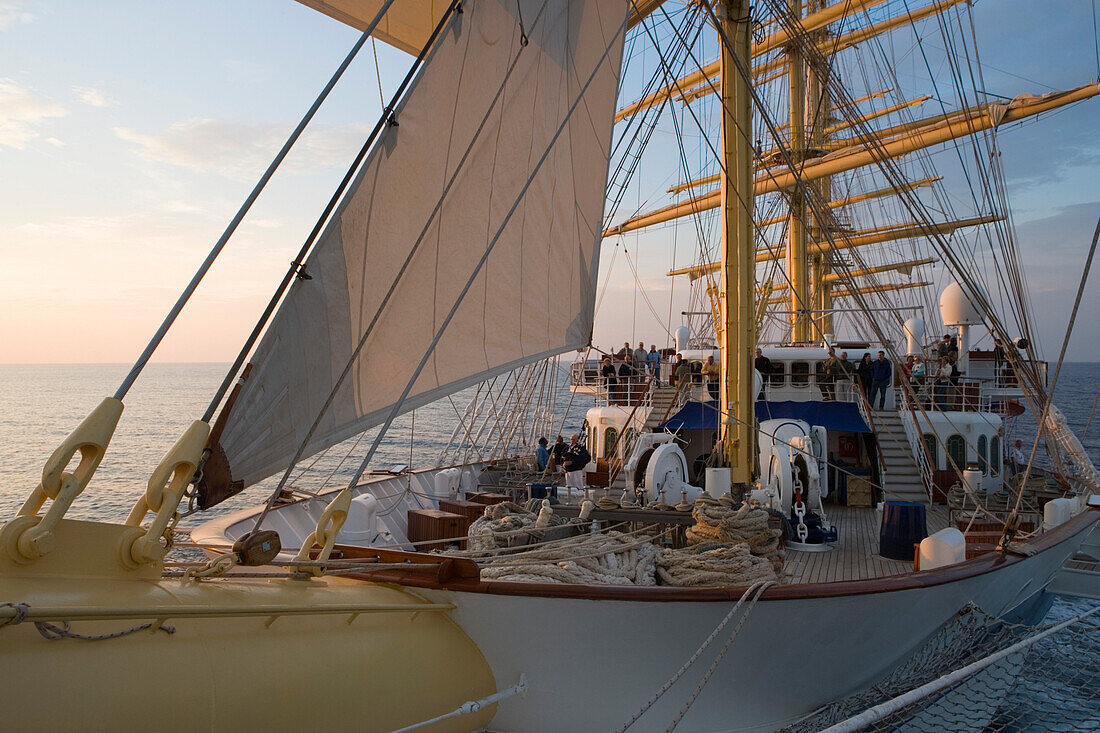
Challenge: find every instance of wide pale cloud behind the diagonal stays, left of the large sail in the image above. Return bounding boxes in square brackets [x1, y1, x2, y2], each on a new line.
[114, 119, 367, 179]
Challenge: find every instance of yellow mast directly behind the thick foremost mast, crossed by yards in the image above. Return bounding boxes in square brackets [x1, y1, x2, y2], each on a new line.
[787, 0, 824, 343]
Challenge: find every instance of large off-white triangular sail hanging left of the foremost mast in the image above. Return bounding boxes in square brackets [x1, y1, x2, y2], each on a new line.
[216, 0, 629, 484]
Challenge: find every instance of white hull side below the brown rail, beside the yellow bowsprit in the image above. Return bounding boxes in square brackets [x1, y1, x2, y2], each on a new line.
[411, 530, 1080, 733]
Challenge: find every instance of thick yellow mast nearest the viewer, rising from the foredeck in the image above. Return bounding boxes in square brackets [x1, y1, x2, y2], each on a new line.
[716, 0, 756, 486]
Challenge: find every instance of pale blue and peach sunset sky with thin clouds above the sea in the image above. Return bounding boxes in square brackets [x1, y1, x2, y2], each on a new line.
[0, 0, 1100, 363]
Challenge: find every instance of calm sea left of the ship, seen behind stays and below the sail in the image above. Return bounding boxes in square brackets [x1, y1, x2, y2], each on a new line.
[0, 363, 593, 519]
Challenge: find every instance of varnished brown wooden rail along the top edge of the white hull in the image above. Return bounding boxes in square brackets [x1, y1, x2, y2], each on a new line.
[353, 508, 1100, 603]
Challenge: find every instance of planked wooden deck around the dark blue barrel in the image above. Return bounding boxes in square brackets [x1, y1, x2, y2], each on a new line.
[783, 504, 948, 583]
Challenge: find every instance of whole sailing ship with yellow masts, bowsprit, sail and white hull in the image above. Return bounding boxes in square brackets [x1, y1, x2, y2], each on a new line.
[0, 0, 1100, 731]
